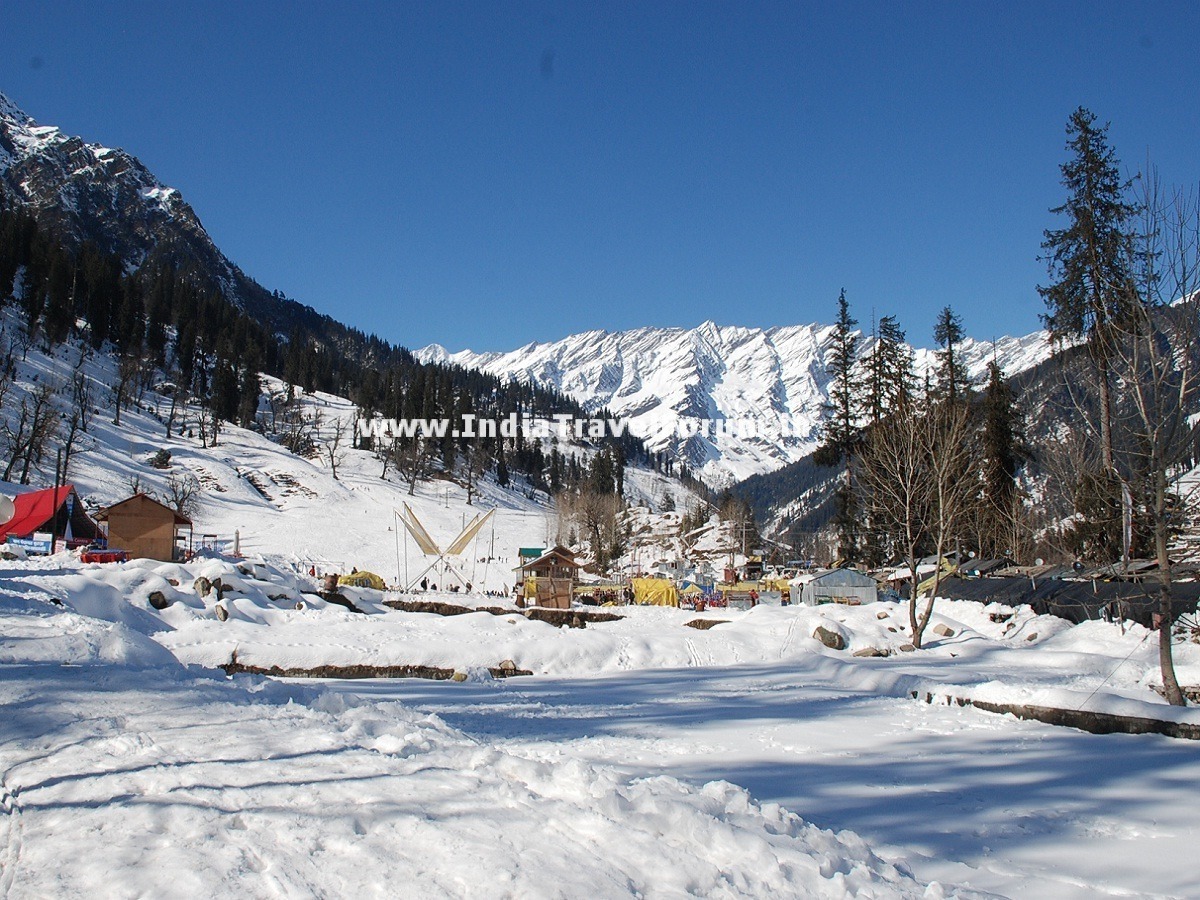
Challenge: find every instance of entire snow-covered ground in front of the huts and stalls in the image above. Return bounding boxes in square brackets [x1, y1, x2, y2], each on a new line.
[0, 556, 1200, 898]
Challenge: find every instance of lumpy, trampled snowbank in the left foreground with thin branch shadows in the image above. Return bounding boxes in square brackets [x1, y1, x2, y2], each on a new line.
[0, 612, 925, 898]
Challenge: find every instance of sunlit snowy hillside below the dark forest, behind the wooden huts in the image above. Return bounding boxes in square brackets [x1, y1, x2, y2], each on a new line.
[0, 310, 691, 592]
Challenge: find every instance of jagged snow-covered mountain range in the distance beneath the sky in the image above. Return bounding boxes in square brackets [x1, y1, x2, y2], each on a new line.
[416, 322, 1050, 485]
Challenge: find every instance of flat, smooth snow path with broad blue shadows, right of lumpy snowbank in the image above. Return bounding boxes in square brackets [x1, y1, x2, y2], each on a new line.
[338, 661, 1200, 898]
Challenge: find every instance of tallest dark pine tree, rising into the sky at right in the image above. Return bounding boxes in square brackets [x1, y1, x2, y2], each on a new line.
[1038, 107, 1136, 469]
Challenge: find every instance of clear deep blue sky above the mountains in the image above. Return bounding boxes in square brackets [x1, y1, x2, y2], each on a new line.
[0, 0, 1200, 349]
